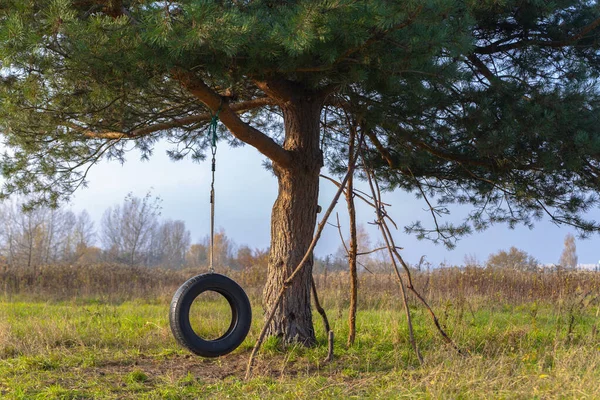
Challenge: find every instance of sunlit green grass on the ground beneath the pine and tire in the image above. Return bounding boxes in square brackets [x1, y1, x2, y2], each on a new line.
[0, 299, 600, 399]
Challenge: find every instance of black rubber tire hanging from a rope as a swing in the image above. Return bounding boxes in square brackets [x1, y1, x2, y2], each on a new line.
[169, 273, 252, 357]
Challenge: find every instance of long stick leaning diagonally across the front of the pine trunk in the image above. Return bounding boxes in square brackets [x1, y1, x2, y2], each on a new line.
[245, 136, 363, 380]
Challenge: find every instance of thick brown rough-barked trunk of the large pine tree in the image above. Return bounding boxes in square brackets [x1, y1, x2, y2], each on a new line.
[264, 96, 323, 345]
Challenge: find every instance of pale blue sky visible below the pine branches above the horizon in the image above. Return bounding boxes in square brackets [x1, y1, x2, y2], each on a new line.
[68, 139, 600, 266]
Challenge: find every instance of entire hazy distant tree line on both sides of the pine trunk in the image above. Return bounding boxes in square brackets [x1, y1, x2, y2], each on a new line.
[0, 192, 578, 273]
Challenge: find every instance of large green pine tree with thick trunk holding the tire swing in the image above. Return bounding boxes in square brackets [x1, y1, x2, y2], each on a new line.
[0, 0, 600, 343]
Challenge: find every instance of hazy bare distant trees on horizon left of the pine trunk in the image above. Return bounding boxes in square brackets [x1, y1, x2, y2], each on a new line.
[0, 193, 267, 269]
